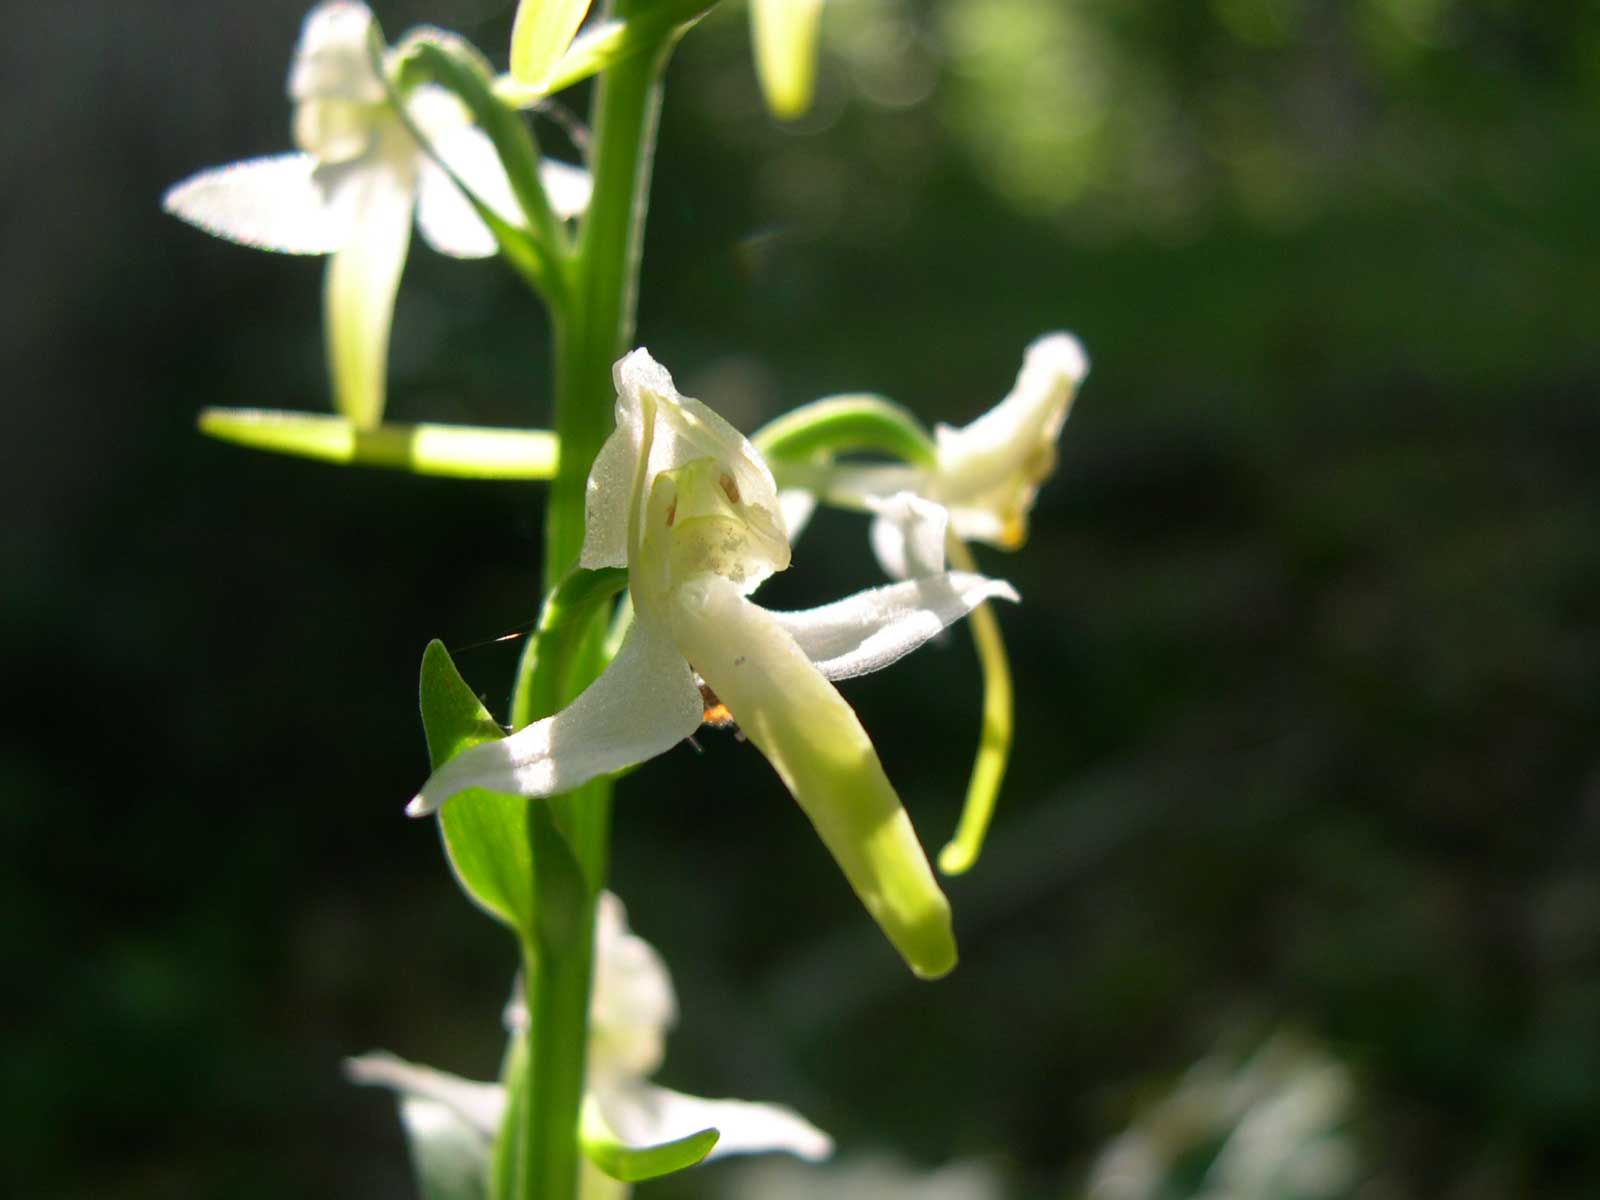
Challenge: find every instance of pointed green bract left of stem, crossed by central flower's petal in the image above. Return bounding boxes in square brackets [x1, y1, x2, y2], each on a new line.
[419, 640, 534, 939]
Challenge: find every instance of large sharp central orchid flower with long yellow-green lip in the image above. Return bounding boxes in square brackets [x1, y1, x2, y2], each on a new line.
[406, 350, 1016, 978]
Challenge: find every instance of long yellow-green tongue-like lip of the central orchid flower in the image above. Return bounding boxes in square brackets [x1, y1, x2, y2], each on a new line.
[667, 574, 955, 978]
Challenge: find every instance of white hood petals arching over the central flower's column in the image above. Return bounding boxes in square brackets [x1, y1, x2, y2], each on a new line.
[579, 349, 789, 592]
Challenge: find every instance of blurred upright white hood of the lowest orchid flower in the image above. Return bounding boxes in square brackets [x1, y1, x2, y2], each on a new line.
[589, 891, 678, 1078]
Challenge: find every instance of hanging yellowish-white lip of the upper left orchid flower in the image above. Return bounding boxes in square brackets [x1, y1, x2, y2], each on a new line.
[323, 155, 416, 429]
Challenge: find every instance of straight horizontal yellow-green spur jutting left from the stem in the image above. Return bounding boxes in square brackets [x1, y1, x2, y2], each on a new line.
[200, 408, 560, 480]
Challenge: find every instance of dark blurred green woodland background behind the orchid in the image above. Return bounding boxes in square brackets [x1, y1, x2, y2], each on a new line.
[0, 0, 1600, 1200]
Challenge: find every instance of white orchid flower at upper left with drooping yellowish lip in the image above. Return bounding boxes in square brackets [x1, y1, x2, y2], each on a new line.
[162, 0, 590, 429]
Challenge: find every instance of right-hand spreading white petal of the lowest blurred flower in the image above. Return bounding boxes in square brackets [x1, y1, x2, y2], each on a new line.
[595, 1083, 834, 1162]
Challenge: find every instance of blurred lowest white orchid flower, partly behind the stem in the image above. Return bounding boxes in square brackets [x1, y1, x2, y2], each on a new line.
[347, 891, 834, 1200]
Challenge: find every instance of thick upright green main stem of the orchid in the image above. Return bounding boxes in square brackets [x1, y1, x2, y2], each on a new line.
[507, 11, 675, 1200]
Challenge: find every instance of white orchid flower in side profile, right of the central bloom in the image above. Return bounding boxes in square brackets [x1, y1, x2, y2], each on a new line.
[784, 333, 1088, 578]
